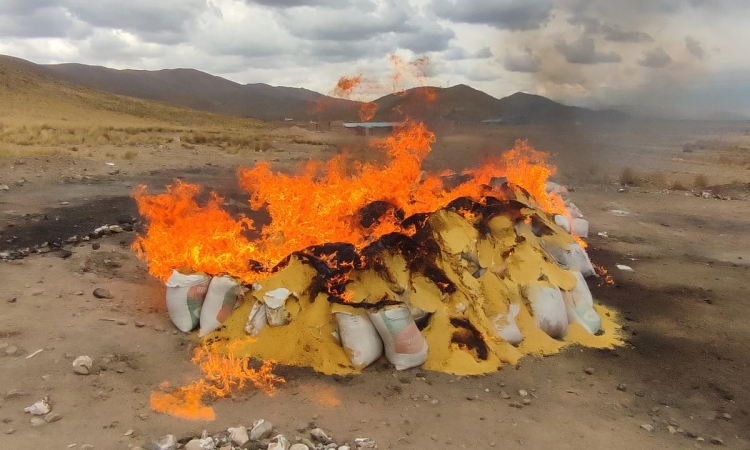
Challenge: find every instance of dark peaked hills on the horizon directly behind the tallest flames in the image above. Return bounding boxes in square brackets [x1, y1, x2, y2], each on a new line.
[375, 84, 627, 123]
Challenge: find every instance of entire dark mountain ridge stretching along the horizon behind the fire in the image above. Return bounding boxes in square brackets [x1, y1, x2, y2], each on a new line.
[0, 55, 628, 124]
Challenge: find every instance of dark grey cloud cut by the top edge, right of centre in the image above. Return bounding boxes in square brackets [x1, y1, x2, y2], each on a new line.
[431, 0, 552, 31]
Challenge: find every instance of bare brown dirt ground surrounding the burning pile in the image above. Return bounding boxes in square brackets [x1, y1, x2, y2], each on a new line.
[0, 123, 750, 449]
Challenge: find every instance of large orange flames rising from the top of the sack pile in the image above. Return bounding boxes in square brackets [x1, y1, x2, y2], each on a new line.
[133, 121, 565, 283]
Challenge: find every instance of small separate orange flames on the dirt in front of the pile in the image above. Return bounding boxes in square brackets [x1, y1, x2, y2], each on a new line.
[151, 341, 285, 420]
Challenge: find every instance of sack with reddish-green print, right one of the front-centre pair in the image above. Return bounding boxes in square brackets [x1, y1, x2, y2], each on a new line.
[370, 306, 427, 370]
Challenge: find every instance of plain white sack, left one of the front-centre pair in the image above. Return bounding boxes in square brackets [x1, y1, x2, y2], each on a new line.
[335, 312, 383, 369]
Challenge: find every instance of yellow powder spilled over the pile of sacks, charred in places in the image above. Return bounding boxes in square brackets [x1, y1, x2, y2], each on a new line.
[209, 208, 622, 375]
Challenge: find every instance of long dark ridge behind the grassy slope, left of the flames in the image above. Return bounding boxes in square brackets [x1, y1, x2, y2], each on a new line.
[44, 64, 359, 120]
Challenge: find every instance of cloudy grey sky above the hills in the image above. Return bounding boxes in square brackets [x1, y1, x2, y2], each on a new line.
[0, 0, 750, 118]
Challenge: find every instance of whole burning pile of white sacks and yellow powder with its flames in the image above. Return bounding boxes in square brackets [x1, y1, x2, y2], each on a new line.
[134, 121, 619, 374]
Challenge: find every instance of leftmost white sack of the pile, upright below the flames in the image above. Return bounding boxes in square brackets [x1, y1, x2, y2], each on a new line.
[166, 270, 211, 333]
